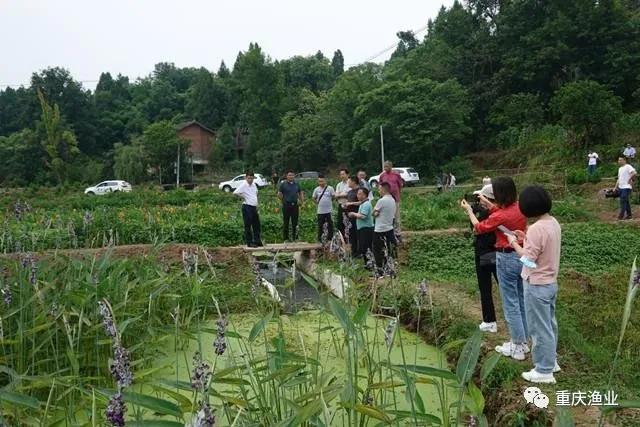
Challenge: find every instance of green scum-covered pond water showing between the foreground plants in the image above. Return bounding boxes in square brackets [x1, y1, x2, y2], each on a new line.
[151, 310, 453, 425]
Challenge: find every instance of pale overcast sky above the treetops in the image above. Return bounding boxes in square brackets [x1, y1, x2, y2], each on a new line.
[0, 0, 453, 90]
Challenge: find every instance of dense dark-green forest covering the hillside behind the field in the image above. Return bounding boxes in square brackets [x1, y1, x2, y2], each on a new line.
[0, 0, 640, 184]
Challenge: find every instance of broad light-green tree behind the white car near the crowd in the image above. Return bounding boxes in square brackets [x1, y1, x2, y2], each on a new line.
[354, 79, 471, 172]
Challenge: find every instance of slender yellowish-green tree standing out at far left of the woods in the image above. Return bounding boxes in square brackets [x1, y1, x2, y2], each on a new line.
[38, 90, 80, 184]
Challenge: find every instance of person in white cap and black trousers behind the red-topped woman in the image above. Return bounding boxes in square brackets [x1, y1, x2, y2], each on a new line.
[471, 181, 498, 332]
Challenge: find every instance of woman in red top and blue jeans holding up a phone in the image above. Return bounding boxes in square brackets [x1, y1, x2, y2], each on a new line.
[460, 177, 529, 360]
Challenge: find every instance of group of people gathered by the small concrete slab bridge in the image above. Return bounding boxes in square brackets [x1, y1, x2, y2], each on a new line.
[234, 161, 404, 275]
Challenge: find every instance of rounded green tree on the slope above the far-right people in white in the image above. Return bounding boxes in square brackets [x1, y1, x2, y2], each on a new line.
[551, 80, 622, 147]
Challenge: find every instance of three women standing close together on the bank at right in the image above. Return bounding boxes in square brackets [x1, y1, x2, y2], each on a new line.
[460, 177, 561, 383]
